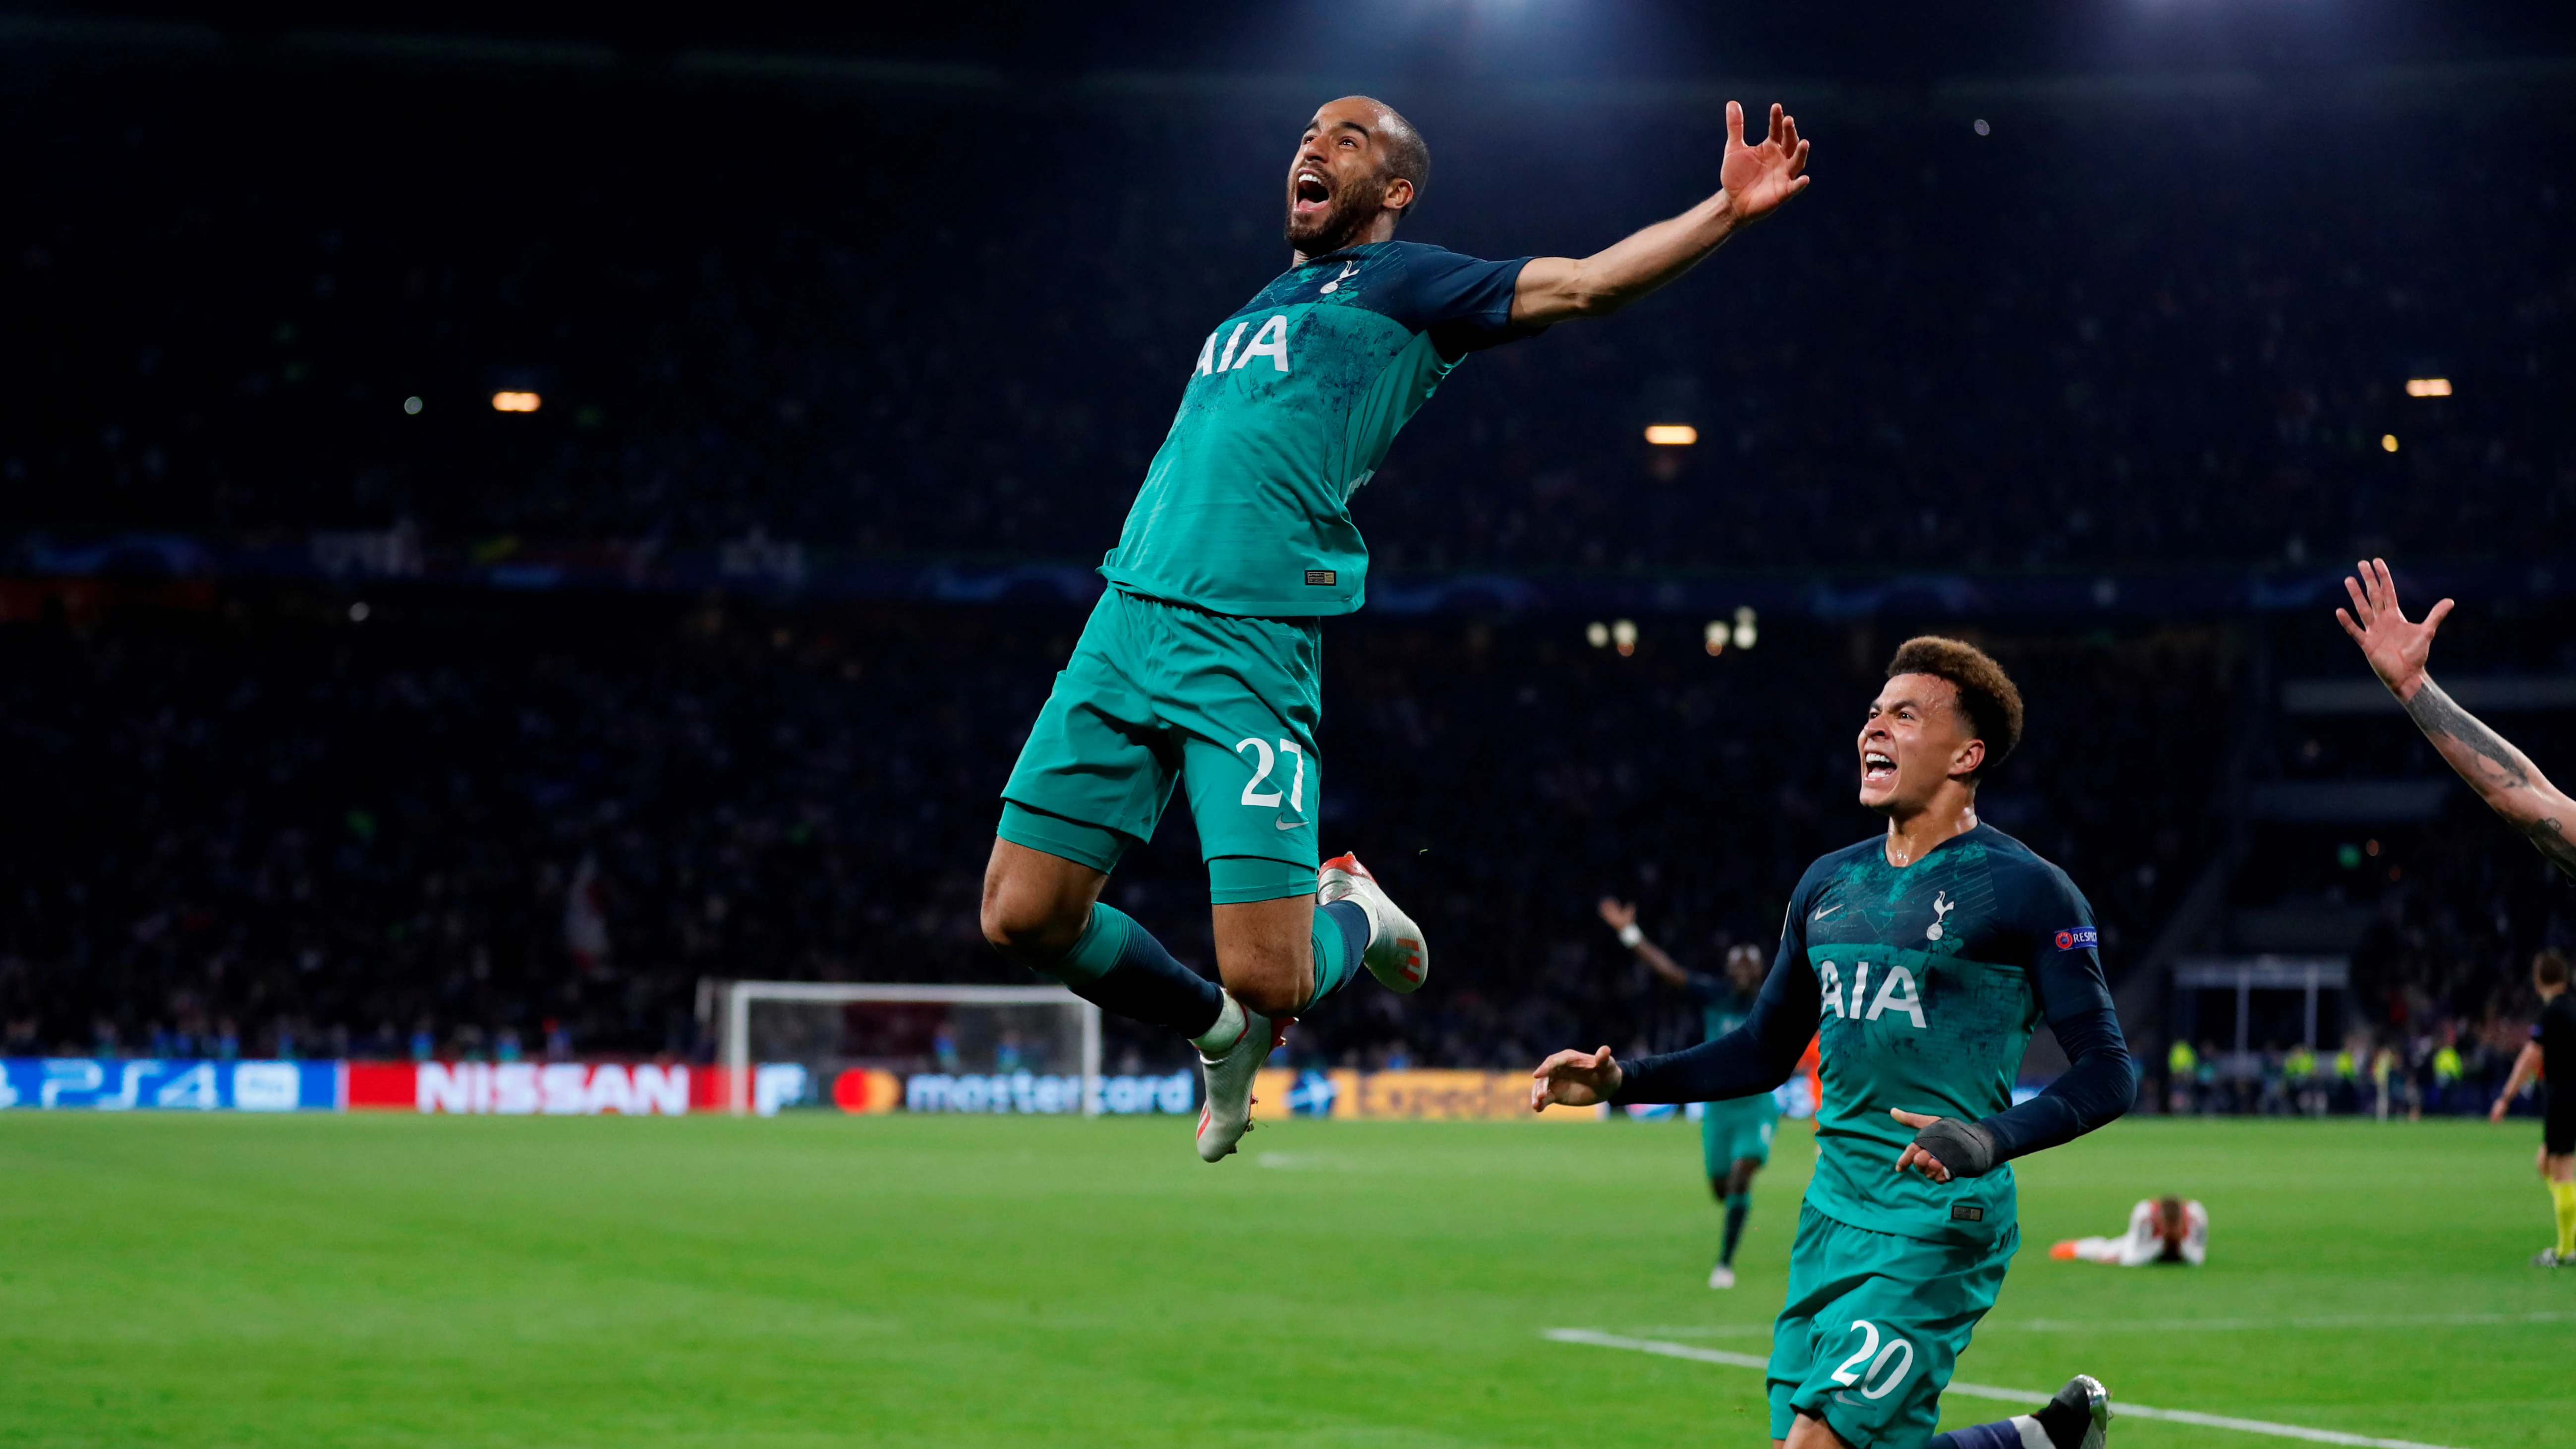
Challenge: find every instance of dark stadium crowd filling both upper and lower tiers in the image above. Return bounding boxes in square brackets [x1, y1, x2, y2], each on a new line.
[0, 51, 2576, 1111]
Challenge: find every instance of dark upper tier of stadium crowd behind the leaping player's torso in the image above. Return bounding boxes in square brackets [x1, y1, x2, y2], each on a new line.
[15, 67, 2576, 570]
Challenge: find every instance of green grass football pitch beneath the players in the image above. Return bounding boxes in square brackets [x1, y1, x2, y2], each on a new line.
[0, 1114, 2576, 1449]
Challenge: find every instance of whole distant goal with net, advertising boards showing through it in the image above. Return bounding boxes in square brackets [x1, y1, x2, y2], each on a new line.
[716, 983, 1100, 1116]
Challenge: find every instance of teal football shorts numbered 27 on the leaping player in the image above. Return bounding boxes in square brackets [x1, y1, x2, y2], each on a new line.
[999, 588, 1324, 905]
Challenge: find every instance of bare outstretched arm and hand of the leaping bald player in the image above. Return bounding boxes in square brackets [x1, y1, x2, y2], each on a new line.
[1512, 101, 1806, 328]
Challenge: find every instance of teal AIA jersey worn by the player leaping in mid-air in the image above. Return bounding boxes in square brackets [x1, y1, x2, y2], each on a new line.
[1100, 242, 1528, 619]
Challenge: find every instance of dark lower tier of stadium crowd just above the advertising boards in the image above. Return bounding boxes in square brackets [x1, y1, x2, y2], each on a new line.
[0, 595, 2226, 1065]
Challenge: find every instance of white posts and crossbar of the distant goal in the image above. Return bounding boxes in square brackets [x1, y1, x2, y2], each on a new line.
[711, 983, 1100, 1116]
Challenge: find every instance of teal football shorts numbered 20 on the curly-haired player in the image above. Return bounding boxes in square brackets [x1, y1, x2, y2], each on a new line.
[1767, 1207, 2022, 1449]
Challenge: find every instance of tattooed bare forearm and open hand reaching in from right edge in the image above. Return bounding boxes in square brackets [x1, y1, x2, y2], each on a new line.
[2334, 549, 2576, 874]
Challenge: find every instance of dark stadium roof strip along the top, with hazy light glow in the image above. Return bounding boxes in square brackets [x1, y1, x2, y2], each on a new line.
[15, 0, 2576, 124]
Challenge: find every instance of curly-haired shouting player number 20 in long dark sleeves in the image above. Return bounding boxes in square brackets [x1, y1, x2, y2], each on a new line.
[1530, 637, 2138, 1449]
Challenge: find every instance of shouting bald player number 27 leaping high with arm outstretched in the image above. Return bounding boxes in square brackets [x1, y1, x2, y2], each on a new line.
[984, 95, 1806, 1163]
